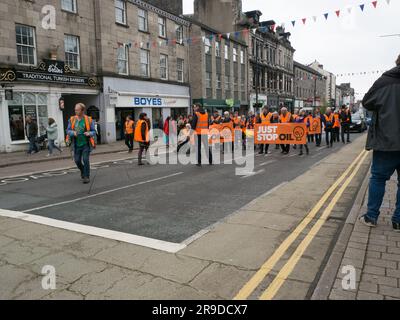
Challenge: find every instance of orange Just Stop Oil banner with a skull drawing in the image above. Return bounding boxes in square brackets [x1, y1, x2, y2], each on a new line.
[254, 123, 307, 144]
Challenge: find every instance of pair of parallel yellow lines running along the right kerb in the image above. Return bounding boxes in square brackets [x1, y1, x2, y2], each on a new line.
[234, 150, 368, 300]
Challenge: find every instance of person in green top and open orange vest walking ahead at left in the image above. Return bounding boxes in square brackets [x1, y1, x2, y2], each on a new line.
[65, 103, 96, 184]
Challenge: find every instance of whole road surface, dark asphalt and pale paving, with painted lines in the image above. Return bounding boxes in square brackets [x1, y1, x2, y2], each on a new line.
[0, 135, 390, 300]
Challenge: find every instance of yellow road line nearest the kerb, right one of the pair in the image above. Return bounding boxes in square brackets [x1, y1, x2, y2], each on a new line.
[260, 153, 368, 300]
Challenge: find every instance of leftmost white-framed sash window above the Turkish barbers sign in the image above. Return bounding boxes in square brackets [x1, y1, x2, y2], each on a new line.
[15, 24, 36, 65]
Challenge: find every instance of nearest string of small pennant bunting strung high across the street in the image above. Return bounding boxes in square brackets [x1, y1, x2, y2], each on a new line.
[118, 0, 391, 49]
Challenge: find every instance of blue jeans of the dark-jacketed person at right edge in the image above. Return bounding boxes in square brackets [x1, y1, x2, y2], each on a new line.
[367, 151, 400, 223]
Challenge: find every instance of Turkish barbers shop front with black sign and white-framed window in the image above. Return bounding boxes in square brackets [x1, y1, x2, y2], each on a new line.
[0, 60, 99, 152]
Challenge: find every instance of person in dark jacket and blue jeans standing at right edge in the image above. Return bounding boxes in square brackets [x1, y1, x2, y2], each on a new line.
[360, 56, 400, 232]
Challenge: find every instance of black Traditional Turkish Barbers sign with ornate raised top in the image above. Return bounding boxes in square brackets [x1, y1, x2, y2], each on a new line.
[0, 60, 98, 87]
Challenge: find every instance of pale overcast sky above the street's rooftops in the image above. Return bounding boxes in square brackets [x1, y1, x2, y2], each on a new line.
[183, 0, 400, 99]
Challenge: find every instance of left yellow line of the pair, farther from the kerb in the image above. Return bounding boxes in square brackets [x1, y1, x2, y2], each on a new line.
[234, 150, 366, 300]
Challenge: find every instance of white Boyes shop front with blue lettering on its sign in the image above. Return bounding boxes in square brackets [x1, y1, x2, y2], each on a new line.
[101, 78, 190, 143]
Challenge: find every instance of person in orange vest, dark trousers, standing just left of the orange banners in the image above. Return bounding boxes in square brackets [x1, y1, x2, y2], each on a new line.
[191, 104, 212, 167]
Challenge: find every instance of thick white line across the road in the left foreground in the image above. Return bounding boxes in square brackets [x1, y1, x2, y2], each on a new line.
[0, 209, 186, 253]
